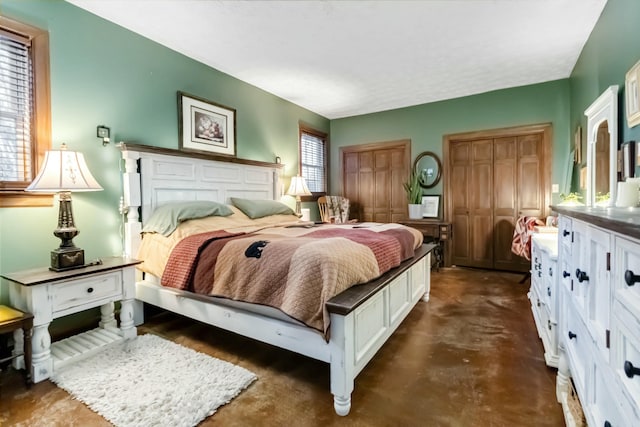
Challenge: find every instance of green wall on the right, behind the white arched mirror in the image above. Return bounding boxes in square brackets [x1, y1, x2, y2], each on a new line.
[570, 0, 640, 172]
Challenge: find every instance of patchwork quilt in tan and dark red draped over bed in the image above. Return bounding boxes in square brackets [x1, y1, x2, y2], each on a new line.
[162, 224, 416, 337]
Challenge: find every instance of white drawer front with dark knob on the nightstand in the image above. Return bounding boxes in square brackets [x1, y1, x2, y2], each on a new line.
[51, 271, 122, 313]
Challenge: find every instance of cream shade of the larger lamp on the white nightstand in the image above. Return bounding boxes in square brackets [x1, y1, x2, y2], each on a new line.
[26, 144, 102, 193]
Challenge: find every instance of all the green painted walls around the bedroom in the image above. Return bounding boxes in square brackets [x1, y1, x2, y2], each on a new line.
[0, 0, 640, 301]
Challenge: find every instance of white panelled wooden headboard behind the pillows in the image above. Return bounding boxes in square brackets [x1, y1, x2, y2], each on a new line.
[120, 143, 282, 257]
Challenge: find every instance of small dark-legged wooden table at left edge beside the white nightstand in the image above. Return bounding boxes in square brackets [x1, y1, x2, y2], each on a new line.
[0, 305, 33, 387]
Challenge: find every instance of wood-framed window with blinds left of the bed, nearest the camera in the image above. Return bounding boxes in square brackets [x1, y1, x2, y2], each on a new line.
[0, 16, 53, 207]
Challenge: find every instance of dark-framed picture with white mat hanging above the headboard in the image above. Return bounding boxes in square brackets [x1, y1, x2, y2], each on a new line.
[178, 91, 236, 157]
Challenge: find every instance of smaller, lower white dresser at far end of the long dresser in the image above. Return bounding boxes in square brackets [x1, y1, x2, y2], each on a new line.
[528, 233, 559, 368]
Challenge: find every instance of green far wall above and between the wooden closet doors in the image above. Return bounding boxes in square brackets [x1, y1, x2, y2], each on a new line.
[331, 79, 570, 199]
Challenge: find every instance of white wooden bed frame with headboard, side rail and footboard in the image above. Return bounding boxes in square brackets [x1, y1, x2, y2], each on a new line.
[120, 143, 435, 416]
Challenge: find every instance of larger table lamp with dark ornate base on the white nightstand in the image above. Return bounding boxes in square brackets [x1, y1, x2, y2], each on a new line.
[26, 144, 102, 271]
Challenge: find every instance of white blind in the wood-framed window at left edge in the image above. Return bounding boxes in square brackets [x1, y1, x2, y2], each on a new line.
[0, 32, 33, 182]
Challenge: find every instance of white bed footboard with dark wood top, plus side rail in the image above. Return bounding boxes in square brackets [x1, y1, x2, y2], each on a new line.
[135, 245, 432, 416]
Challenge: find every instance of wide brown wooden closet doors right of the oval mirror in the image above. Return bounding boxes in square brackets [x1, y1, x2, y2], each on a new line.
[443, 125, 551, 271]
